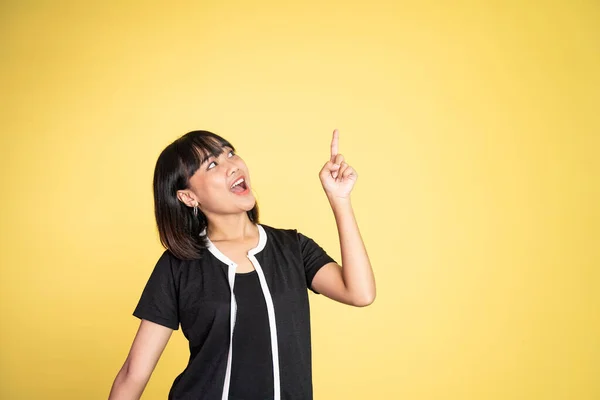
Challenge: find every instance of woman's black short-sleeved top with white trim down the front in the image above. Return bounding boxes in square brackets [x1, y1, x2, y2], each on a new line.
[133, 225, 334, 400]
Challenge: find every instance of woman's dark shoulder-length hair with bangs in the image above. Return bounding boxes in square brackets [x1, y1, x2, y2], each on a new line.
[153, 131, 258, 260]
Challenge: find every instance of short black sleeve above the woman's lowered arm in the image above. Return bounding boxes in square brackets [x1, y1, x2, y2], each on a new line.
[133, 250, 179, 330]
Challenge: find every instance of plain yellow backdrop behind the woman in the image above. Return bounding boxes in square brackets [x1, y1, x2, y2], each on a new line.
[0, 0, 600, 400]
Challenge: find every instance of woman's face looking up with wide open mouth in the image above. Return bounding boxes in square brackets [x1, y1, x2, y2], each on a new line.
[190, 147, 256, 216]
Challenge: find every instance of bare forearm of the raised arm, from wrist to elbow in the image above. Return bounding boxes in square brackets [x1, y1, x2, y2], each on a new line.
[328, 197, 376, 306]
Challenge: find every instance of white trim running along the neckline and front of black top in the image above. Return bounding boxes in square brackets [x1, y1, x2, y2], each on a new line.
[201, 224, 281, 400]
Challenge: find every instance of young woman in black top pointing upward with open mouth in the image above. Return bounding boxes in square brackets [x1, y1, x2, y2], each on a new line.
[109, 130, 375, 400]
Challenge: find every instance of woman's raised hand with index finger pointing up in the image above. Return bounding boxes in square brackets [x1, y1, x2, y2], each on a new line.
[319, 129, 358, 200]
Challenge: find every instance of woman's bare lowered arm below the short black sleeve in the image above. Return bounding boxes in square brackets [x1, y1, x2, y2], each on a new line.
[108, 319, 173, 400]
